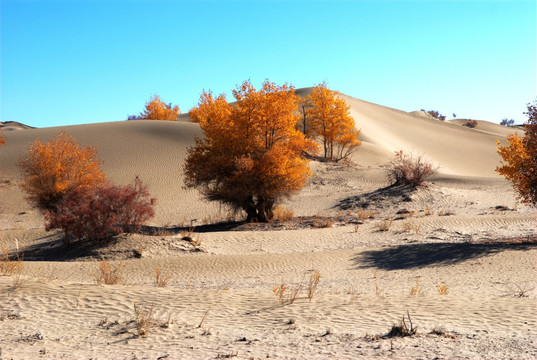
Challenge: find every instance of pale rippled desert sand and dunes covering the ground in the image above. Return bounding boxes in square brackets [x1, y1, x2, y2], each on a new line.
[0, 89, 537, 359]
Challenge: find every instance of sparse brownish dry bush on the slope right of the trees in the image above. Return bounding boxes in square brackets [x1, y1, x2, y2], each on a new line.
[384, 151, 437, 187]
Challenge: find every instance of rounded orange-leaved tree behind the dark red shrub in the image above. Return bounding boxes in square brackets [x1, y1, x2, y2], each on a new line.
[19, 132, 106, 211]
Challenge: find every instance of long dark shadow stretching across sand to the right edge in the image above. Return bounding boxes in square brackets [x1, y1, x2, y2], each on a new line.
[351, 239, 537, 270]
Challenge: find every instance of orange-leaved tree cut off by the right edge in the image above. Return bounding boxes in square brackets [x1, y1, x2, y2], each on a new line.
[496, 100, 537, 206]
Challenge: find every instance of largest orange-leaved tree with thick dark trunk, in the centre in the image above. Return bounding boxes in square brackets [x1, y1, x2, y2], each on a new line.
[184, 80, 316, 222]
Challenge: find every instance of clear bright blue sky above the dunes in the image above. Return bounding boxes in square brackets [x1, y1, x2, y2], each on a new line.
[0, 0, 537, 127]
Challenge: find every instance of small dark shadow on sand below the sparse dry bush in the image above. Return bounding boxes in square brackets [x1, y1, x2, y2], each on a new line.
[334, 185, 416, 210]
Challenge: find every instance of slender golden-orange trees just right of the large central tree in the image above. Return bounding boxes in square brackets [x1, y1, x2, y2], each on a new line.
[304, 83, 360, 161]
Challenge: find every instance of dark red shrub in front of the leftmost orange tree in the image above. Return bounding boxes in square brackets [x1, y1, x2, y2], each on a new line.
[45, 177, 155, 244]
